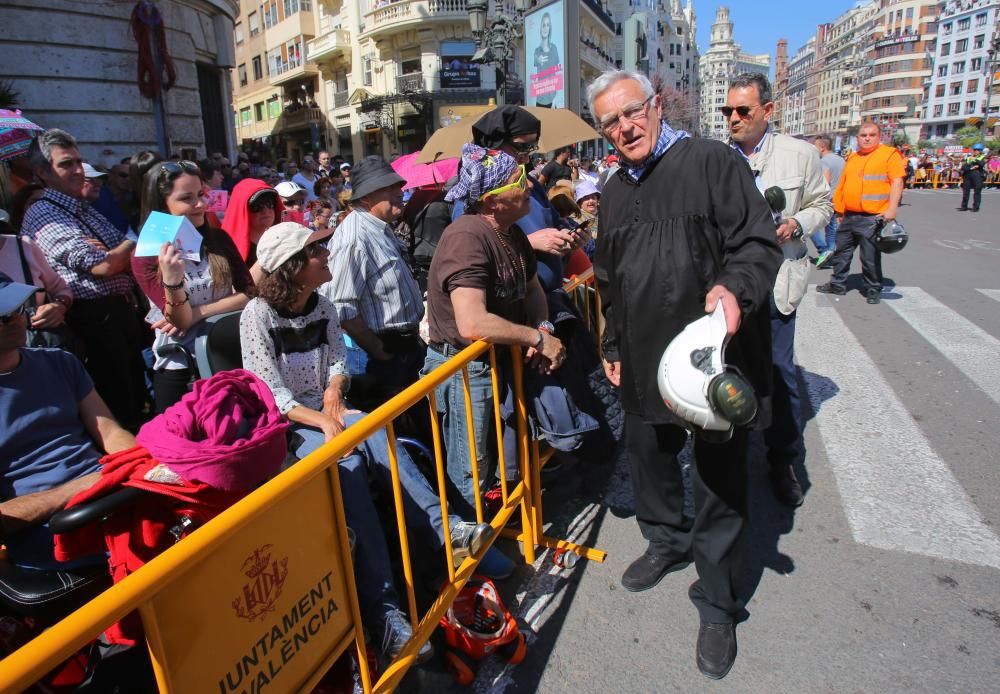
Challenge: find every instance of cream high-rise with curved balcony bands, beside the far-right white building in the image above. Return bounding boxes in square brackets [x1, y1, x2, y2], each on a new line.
[861, 0, 936, 142]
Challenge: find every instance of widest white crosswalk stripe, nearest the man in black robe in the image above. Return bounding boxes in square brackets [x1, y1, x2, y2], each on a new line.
[796, 291, 1000, 568]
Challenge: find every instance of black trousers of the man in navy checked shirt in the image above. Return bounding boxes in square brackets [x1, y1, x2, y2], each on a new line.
[66, 295, 146, 429]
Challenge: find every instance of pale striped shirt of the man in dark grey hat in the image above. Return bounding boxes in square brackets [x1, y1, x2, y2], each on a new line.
[320, 209, 424, 333]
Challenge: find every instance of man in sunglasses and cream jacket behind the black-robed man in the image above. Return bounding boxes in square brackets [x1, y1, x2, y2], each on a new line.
[721, 73, 833, 508]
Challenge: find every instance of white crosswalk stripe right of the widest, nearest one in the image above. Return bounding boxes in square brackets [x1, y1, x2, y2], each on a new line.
[885, 287, 1000, 405]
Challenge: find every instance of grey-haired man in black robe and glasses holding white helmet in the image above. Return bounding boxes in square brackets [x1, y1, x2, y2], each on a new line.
[587, 71, 782, 679]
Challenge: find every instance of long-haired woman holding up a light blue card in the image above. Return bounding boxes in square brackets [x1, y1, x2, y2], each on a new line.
[132, 161, 253, 412]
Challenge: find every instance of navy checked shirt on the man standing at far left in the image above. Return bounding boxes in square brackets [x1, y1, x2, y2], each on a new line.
[23, 188, 135, 299]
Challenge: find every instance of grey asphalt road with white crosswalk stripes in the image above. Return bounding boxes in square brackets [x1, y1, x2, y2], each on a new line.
[473, 191, 1000, 694]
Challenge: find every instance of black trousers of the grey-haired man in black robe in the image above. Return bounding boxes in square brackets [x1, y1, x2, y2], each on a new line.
[625, 413, 748, 623]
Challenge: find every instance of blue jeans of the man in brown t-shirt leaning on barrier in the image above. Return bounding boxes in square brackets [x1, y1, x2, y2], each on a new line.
[421, 345, 496, 518]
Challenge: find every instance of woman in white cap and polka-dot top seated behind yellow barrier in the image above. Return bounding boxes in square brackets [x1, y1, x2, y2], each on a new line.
[240, 222, 496, 661]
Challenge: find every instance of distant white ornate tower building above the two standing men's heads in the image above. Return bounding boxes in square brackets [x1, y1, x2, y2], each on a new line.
[699, 7, 771, 140]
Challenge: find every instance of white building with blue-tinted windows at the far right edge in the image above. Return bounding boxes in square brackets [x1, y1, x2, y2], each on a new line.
[922, 0, 1000, 138]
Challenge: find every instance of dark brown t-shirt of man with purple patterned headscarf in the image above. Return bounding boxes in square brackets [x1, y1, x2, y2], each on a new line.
[427, 214, 536, 347]
